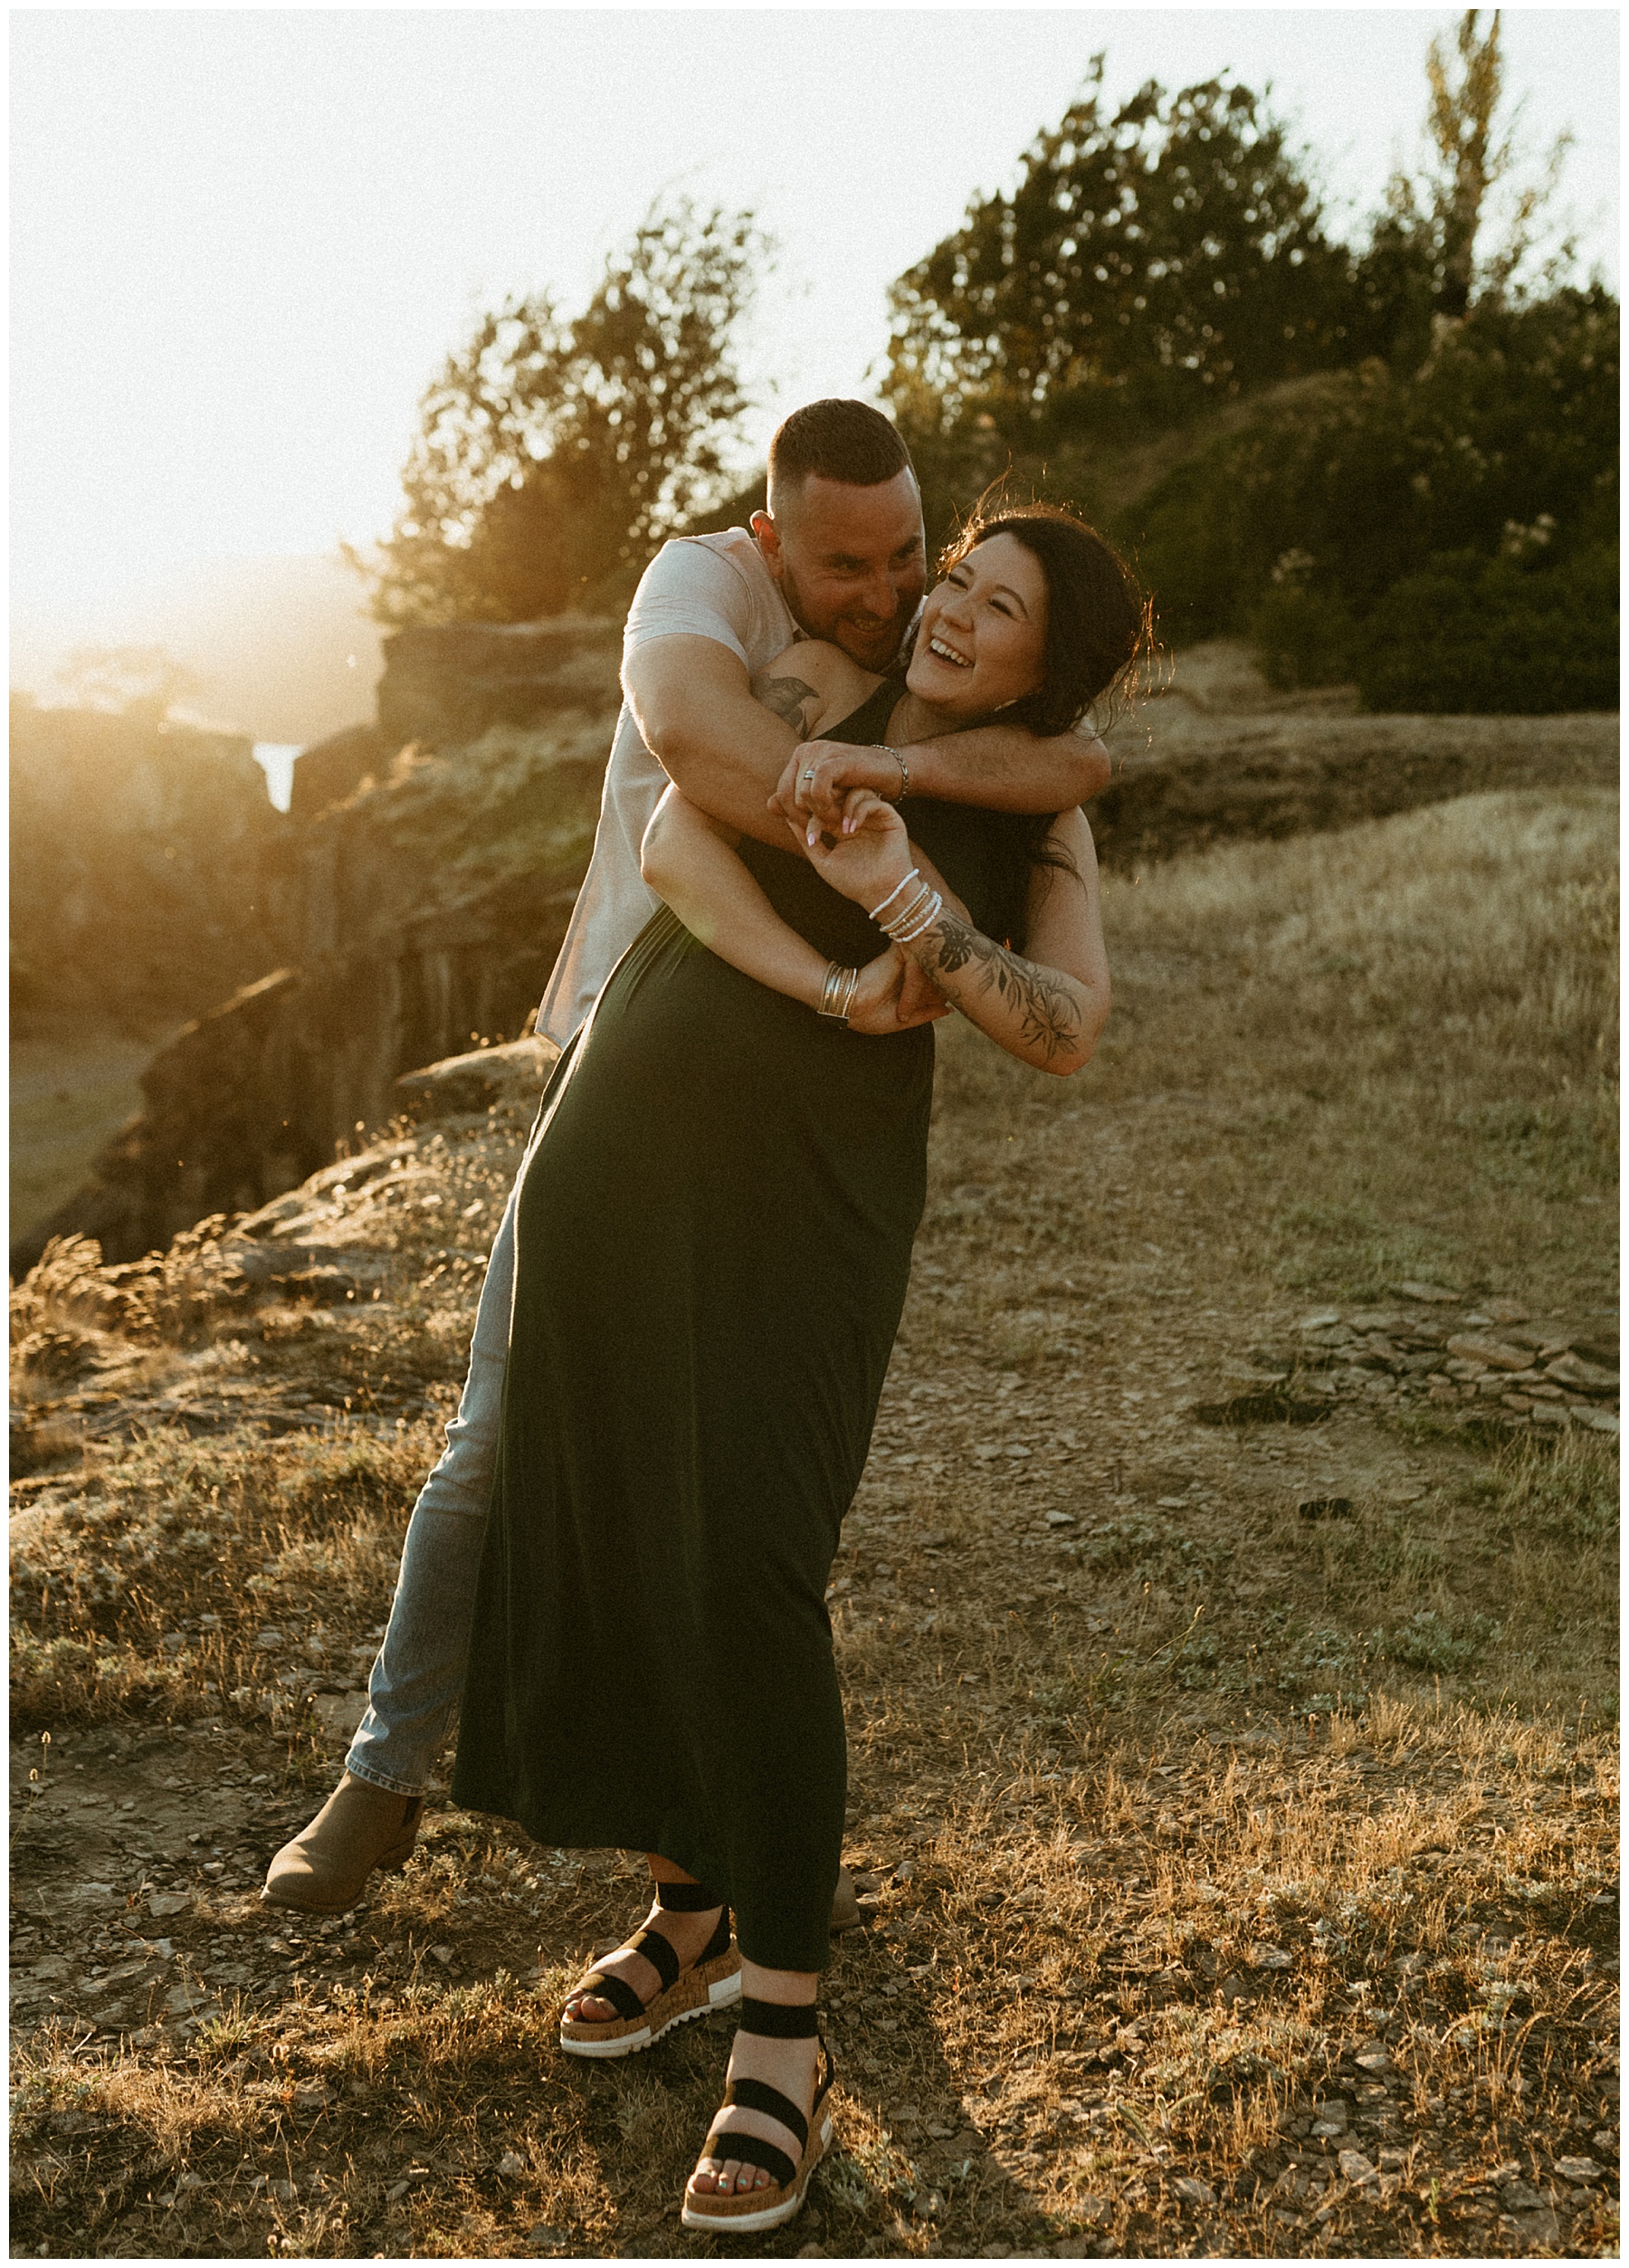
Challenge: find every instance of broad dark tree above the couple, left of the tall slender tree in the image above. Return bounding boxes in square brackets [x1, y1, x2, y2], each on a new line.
[890, 54, 1350, 440]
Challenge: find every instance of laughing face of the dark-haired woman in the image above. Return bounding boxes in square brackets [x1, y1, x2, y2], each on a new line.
[905, 535, 1046, 717]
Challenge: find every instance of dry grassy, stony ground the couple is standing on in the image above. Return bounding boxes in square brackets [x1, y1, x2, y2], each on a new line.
[14, 789, 1617, 2256]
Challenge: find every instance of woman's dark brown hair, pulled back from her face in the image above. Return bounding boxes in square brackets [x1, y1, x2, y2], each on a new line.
[939, 499, 1153, 739]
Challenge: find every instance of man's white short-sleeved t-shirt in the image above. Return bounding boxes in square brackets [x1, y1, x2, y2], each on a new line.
[538, 529, 798, 1045]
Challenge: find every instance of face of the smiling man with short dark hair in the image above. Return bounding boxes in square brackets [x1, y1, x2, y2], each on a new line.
[753, 472, 928, 669]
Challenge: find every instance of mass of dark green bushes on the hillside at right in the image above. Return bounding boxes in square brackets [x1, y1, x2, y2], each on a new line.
[1114, 291, 1617, 666]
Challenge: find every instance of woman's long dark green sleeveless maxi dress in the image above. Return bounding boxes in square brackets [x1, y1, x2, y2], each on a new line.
[452, 682, 1028, 1971]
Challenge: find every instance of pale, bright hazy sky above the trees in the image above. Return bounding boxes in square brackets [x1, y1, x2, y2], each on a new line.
[12, 7, 1617, 624]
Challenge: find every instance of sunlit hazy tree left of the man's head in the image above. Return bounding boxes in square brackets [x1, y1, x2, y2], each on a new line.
[358, 197, 769, 626]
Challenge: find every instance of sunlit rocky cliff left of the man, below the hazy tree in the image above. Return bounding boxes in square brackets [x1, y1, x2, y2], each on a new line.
[12, 617, 619, 1268]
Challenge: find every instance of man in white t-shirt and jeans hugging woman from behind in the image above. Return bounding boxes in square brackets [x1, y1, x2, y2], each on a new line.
[263, 402, 1110, 1926]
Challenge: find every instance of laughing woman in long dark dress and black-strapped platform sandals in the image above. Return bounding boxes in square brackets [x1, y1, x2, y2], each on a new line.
[453, 506, 1146, 2234]
